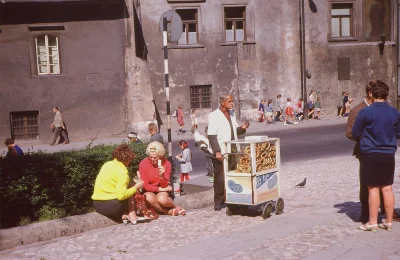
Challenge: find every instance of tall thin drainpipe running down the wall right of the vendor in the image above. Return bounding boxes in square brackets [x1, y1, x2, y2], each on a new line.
[299, 0, 308, 120]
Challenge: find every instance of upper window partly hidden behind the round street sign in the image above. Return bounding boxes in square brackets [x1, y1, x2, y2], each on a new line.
[176, 9, 199, 44]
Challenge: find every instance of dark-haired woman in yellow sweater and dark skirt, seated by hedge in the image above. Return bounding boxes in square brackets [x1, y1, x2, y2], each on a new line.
[92, 144, 143, 224]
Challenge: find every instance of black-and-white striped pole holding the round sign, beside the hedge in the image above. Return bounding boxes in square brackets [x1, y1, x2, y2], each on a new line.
[163, 17, 175, 199]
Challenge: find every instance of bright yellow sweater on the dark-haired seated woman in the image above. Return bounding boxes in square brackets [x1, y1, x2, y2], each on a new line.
[92, 159, 136, 200]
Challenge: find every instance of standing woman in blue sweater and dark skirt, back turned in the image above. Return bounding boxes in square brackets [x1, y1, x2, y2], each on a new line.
[352, 80, 400, 232]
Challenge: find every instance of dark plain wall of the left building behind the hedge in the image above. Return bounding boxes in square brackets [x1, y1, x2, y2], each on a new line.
[0, 0, 152, 142]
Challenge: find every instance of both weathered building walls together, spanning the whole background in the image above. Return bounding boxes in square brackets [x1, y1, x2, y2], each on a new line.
[0, 0, 400, 142]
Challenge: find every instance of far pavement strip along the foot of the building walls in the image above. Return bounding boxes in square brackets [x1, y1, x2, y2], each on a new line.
[0, 116, 347, 156]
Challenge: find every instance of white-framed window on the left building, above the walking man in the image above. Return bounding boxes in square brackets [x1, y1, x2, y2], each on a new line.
[35, 34, 60, 75]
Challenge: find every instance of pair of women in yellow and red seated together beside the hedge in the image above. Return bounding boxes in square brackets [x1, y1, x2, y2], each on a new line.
[92, 141, 186, 224]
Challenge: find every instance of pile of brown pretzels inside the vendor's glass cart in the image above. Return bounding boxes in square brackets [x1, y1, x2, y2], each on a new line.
[235, 142, 276, 173]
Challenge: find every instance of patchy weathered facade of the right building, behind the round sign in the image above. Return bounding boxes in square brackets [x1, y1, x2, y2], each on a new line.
[141, 0, 397, 121]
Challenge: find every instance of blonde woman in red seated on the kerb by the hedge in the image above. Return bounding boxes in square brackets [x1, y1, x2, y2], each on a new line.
[139, 141, 186, 216]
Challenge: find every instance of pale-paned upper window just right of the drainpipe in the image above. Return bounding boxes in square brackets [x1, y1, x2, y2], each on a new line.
[331, 3, 354, 39]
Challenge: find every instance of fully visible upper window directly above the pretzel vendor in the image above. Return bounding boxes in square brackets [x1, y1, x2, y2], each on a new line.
[224, 6, 246, 42]
